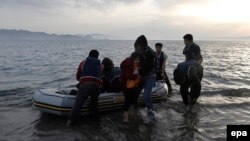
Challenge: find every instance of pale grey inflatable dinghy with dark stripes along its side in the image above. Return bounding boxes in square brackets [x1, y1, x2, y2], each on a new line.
[32, 82, 168, 116]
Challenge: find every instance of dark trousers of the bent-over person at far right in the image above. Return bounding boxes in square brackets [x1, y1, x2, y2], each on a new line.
[180, 67, 201, 105]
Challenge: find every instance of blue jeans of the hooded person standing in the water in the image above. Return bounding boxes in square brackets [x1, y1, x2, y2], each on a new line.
[138, 76, 155, 111]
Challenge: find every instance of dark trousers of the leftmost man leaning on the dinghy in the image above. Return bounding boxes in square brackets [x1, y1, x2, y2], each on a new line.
[69, 83, 100, 121]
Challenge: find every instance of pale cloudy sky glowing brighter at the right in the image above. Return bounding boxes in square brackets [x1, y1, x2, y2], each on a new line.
[0, 0, 250, 40]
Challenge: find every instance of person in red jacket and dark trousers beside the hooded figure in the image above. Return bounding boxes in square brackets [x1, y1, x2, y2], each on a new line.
[120, 52, 140, 122]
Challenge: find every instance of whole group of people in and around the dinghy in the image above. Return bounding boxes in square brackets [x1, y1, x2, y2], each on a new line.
[67, 34, 203, 125]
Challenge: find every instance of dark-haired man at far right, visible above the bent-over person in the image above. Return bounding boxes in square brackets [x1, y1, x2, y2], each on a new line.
[183, 34, 203, 64]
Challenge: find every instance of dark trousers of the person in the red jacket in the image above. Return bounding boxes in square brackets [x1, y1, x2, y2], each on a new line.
[123, 88, 139, 111]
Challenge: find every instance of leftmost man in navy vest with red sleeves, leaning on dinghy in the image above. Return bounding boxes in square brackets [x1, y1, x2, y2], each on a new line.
[67, 50, 103, 125]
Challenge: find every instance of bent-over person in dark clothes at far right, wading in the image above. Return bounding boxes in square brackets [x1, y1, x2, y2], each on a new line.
[174, 60, 203, 111]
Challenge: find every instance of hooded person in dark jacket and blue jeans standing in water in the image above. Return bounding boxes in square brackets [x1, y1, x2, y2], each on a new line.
[134, 35, 155, 122]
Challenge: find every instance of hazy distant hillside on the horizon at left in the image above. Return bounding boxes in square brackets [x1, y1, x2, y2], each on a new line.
[0, 29, 96, 40]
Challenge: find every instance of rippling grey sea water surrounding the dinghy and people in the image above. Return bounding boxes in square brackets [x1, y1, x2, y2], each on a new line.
[0, 40, 250, 141]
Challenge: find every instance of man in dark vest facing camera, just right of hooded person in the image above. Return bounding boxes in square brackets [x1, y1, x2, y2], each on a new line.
[155, 43, 172, 93]
